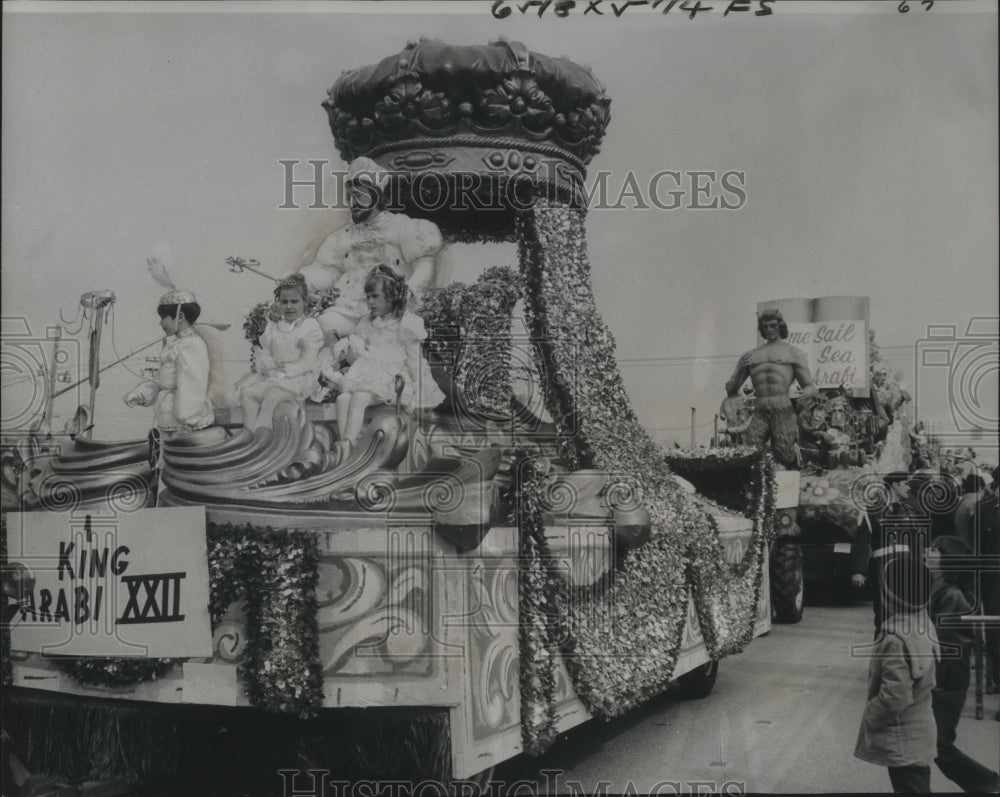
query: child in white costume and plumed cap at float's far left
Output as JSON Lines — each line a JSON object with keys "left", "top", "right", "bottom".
{"left": 125, "top": 290, "right": 215, "bottom": 436}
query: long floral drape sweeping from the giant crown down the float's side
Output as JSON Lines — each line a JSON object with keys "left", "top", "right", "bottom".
{"left": 518, "top": 196, "right": 767, "bottom": 718}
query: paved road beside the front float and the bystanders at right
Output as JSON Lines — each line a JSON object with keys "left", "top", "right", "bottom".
{"left": 494, "top": 604, "right": 1000, "bottom": 794}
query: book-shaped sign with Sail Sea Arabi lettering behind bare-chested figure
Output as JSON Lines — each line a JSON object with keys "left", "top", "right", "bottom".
{"left": 757, "top": 296, "right": 869, "bottom": 398}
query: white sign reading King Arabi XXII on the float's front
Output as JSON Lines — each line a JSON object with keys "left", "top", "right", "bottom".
{"left": 7, "top": 505, "right": 212, "bottom": 658}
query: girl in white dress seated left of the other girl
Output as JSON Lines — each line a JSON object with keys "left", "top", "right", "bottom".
{"left": 236, "top": 274, "right": 323, "bottom": 430}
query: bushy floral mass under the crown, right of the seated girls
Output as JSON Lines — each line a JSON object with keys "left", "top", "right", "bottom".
{"left": 420, "top": 266, "right": 521, "bottom": 417}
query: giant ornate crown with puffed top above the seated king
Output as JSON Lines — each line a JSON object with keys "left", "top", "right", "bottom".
{"left": 323, "top": 40, "right": 611, "bottom": 230}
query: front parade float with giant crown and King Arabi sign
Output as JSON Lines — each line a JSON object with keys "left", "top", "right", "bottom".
{"left": 3, "top": 41, "right": 775, "bottom": 790}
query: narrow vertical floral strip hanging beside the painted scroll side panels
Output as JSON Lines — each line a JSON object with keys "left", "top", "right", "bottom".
{"left": 511, "top": 451, "right": 562, "bottom": 755}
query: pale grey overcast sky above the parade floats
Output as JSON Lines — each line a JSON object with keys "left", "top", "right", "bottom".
{"left": 2, "top": 0, "right": 998, "bottom": 454}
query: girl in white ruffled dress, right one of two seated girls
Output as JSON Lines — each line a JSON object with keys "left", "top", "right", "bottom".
{"left": 321, "top": 265, "right": 444, "bottom": 451}
